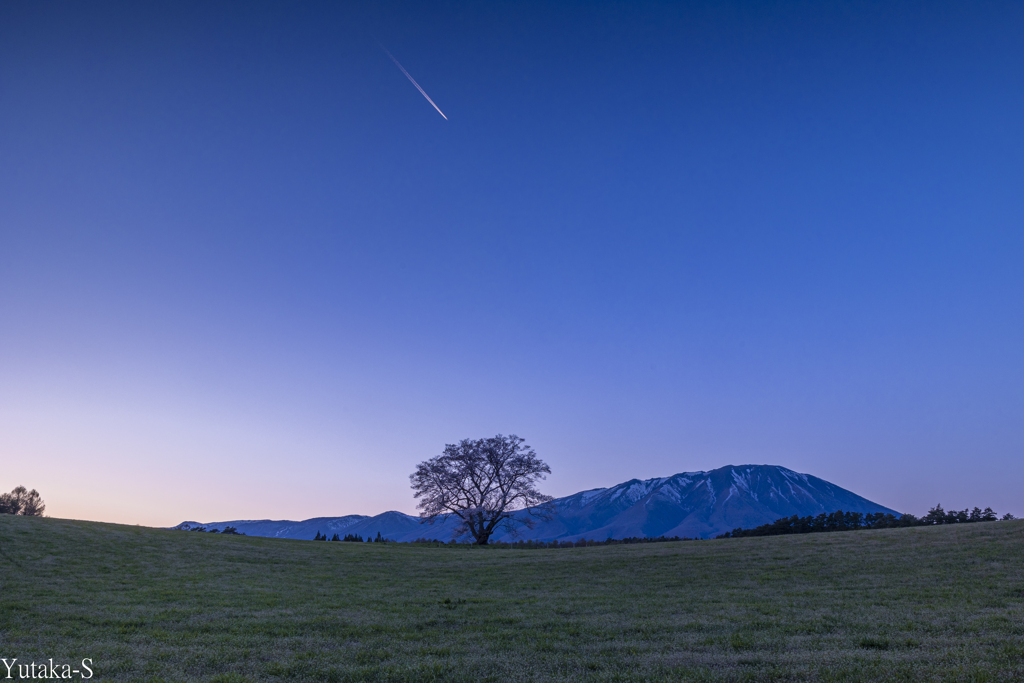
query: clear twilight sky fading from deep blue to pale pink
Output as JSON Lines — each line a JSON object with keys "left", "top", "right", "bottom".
{"left": 0, "top": 2, "right": 1024, "bottom": 526}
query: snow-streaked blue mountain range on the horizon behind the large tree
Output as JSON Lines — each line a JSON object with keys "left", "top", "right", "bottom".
{"left": 174, "top": 465, "right": 899, "bottom": 542}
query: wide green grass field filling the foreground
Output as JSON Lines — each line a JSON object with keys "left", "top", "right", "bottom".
{"left": 0, "top": 515, "right": 1024, "bottom": 683}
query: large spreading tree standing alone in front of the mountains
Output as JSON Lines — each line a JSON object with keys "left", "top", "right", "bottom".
{"left": 409, "top": 434, "right": 553, "bottom": 546}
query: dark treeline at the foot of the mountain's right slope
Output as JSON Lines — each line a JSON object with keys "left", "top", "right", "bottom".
{"left": 716, "top": 505, "right": 1014, "bottom": 539}
